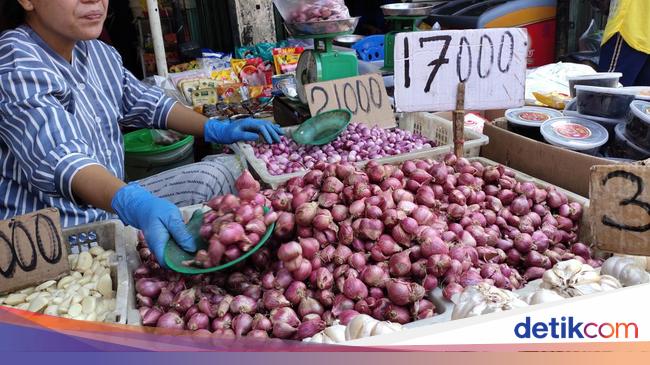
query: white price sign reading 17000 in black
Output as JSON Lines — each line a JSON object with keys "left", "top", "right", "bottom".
{"left": 395, "top": 28, "right": 528, "bottom": 112}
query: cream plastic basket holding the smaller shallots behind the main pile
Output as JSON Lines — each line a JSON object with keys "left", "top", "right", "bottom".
{"left": 234, "top": 113, "right": 490, "bottom": 189}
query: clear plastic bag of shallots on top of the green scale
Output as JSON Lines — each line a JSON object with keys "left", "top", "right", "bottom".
{"left": 273, "top": 0, "right": 350, "bottom": 23}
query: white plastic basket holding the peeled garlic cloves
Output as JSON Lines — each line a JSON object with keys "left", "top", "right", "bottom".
{"left": 62, "top": 220, "right": 133, "bottom": 324}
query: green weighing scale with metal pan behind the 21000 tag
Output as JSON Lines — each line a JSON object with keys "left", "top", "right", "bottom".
{"left": 286, "top": 17, "right": 359, "bottom": 104}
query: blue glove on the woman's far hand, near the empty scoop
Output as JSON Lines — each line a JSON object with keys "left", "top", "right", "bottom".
{"left": 204, "top": 118, "right": 284, "bottom": 144}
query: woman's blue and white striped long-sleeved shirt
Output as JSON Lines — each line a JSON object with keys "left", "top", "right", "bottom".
{"left": 0, "top": 26, "right": 174, "bottom": 227}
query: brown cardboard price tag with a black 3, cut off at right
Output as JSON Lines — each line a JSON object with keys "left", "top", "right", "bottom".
{"left": 590, "top": 165, "right": 650, "bottom": 256}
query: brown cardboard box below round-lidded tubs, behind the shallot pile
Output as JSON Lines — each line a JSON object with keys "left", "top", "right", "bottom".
{"left": 481, "top": 121, "right": 615, "bottom": 197}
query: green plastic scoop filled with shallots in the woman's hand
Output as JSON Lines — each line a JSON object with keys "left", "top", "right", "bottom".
{"left": 165, "top": 207, "right": 275, "bottom": 275}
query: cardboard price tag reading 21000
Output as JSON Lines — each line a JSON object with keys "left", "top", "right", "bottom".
{"left": 305, "top": 74, "right": 396, "bottom": 128}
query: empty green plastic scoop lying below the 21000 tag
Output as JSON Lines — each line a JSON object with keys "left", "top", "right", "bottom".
{"left": 291, "top": 109, "right": 352, "bottom": 146}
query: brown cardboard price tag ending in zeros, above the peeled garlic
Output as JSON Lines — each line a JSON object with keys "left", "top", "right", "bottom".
{"left": 0, "top": 209, "right": 70, "bottom": 293}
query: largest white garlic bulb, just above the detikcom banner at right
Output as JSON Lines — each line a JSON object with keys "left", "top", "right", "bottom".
{"left": 540, "top": 260, "right": 622, "bottom": 298}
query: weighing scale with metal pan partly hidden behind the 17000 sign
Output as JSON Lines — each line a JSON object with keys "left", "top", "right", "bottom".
{"left": 381, "top": 3, "right": 434, "bottom": 72}
